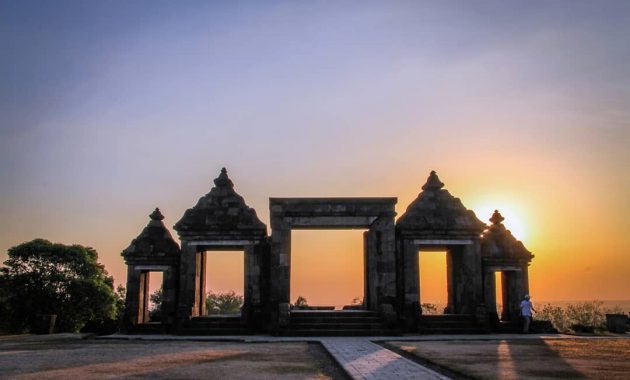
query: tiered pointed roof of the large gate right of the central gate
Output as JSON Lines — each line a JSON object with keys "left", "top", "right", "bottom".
{"left": 396, "top": 171, "right": 486, "bottom": 239}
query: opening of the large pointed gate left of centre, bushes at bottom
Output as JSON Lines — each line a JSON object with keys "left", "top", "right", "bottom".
{"left": 204, "top": 250, "right": 245, "bottom": 315}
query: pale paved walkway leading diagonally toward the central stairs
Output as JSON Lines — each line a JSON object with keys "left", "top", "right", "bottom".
{"left": 320, "top": 338, "right": 449, "bottom": 380}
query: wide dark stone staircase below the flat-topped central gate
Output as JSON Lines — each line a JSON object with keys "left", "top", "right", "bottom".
{"left": 279, "top": 310, "right": 400, "bottom": 336}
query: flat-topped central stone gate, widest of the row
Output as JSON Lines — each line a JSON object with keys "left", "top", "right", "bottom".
{"left": 269, "top": 198, "right": 397, "bottom": 326}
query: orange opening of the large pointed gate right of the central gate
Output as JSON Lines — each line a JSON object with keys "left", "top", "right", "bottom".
{"left": 418, "top": 249, "right": 448, "bottom": 314}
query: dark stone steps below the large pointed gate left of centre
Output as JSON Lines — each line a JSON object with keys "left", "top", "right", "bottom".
{"left": 178, "top": 315, "right": 252, "bottom": 335}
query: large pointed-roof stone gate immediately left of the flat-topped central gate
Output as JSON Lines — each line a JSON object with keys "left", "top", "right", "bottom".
{"left": 174, "top": 168, "right": 267, "bottom": 327}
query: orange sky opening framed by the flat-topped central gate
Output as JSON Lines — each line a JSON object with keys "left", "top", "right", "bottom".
{"left": 290, "top": 230, "right": 365, "bottom": 310}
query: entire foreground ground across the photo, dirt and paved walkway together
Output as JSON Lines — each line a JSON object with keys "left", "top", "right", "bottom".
{"left": 0, "top": 334, "right": 630, "bottom": 380}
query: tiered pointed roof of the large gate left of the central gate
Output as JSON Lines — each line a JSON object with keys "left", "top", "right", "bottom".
{"left": 174, "top": 168, "right": 267, "bottom": 240}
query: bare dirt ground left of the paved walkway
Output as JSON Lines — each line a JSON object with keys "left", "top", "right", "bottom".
{"left": 0, "top": 334, "right": 347, "bottom": 380}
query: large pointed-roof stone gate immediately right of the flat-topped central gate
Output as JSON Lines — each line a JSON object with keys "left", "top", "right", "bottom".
{"left": 396, "top": 171, "right": 486, "bottom": 329}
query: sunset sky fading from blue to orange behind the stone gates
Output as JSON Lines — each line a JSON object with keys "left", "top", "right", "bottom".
{"left": 0, "top": 0, "right": 630, "bottom": 302}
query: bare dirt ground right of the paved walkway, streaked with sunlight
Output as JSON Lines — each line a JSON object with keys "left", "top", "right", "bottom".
{"left": 386, "top": 339, "right": 630, "bottom": 379}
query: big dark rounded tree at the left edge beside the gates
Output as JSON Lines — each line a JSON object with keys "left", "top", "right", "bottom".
{"left": 0, "top": 239, "right": 116, "bottom": 331}
